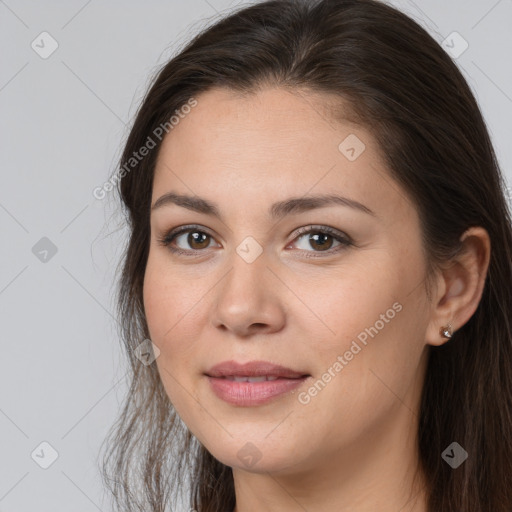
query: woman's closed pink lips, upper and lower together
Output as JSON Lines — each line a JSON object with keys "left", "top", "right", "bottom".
{"left": 205, "top": 361, "right": 310, "bottom": 407}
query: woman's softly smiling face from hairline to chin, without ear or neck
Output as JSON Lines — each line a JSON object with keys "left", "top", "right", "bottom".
{"left": 144, "top": 88, "right": 431, "bottom": 474}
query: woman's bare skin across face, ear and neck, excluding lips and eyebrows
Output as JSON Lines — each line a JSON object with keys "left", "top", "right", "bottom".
{"left": 144, "top": 87, "right": 490, "bottom": 512}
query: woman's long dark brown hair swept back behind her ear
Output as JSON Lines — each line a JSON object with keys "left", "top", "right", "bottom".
{"left": 99, "top": 0, "right": 512, "bottom": 512}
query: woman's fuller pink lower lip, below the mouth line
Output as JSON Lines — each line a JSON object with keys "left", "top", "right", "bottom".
{"left": 204, "top": 377, "right": 308, "bottom": 407}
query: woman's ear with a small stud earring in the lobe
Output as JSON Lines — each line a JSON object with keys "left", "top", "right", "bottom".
{"left": 425, "top": 227, "right": 491, "bottom": 346}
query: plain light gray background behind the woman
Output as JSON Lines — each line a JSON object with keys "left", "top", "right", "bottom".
{"left": 0, "top": 0, "right": 512, "bottom": 512}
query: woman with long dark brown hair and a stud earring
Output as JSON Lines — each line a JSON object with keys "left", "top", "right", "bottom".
{"left": 100, "top": 0, "right": 512, "bottom": 512}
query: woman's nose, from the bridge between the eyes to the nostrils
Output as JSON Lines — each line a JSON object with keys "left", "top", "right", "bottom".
{"left": 212, "top": 246, "right": 287, "bottom": 337}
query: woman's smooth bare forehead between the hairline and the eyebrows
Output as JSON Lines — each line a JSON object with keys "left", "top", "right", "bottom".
{"left": 153, "top": 88, "right": 414, "bottom": 224}
